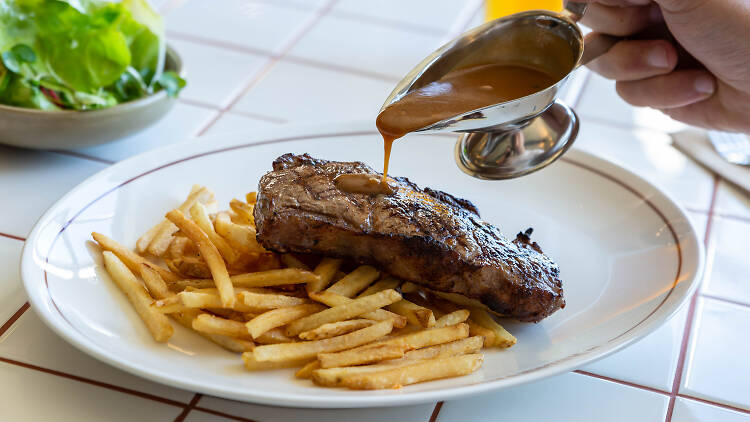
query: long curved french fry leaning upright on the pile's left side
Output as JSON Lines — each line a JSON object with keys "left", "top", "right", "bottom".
{"left": 167, "top": 210, "right": 236, "bottom": 308}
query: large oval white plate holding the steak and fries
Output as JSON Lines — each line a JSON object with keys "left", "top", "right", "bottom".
{"left": 21, "top": 123, "right": 703, "bottom": 407}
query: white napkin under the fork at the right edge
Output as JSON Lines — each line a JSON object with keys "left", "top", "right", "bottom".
{"left": 672, "top": 129, "right": 750, "bottom": 194}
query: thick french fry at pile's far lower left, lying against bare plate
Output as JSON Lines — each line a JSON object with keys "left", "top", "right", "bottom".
{"left": 103, "top": 251, "right": 174, "bottom": 342}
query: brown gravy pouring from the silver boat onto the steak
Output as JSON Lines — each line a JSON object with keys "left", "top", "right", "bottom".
{"left": 358, "top": 64, "right": 558, "bottom": 194}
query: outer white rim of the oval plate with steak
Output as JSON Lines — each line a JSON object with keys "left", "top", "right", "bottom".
{"left": 20, "top": 121, "right": 705, "bottom": 408}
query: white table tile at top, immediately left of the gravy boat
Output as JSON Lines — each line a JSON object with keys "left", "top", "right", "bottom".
{"left": 289, "top": 14, "right": 441, "bottom": 79}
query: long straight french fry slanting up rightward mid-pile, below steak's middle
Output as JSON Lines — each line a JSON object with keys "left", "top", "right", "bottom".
{"left": 286, "top": 290, "right": 401, "bottom": 336}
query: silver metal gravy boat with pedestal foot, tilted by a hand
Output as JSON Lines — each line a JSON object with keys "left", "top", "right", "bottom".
{"left": 381, "top": 2, "right": 616, "bottom": 180}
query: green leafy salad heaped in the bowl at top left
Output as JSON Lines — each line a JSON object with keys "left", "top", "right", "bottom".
{"left": 0, "top": 0, "right": 185, "bottom": 110}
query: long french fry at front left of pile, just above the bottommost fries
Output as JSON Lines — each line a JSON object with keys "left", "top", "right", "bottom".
{"left": 253, "top": 320, "right": 393, "bottom": 362}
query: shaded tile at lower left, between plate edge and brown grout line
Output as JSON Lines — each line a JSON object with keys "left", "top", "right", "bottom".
{"left": 0, "top": 309, "right": 194, "bottom": 403}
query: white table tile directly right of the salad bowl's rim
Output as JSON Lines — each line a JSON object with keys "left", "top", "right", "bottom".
{"left": 169, "top": 37, "right": 269, "bottom": 107}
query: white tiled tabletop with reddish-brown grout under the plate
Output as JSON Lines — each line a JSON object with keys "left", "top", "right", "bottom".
{"left": 0, "top": 0, "right": 750, "bottom": 422}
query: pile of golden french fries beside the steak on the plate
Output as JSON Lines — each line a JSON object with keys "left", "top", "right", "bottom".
{"left": 92, "top": 186, "right": 516, "bottom": 389}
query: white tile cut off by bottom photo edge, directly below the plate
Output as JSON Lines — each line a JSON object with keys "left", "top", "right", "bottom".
{"left": 197, "top": 396, "right": 435, "bottom": 422}
